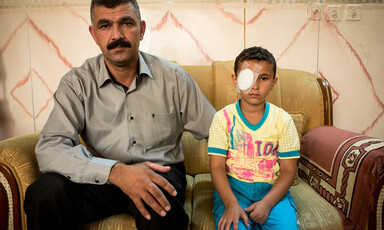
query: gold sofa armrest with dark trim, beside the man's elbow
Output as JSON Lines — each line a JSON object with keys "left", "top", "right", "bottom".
{"left": 0, "top": 133, "right": 40, "bottom": 229}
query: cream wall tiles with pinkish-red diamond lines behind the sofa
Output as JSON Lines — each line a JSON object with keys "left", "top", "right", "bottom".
{"left": 0, "top": 0, "right": 384, "bottom": 140}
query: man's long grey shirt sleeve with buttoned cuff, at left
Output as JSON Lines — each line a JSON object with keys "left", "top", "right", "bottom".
{"left": 36, "top": 78, "right": 116, "bottom": 184}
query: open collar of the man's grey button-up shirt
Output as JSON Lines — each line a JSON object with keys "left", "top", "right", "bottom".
{"left": 97, "top": 52, "right": 153, "bottom": 88}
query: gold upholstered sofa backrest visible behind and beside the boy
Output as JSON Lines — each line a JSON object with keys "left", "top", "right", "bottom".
{"left": 182, "top": 61, "right": 333, "bottom": 175}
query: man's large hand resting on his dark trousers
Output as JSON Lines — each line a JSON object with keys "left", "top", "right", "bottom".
{"left": 109, "top": 162, "right": 177, "bottom": 220}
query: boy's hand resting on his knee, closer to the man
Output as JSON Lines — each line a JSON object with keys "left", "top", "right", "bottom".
{"left": 218, "top": 202, "right": 249, "bottom": 230}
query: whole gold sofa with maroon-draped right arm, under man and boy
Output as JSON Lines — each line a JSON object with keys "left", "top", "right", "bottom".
{"left": 0, "top": 61, "right": 384, "bottom": 230}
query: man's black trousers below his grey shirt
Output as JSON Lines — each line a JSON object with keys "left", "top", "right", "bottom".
{"left": 24, "top": 163, "right": 188, "bottom": 230}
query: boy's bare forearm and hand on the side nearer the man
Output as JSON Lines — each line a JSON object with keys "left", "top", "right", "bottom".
{"left": 210, "top": 155, "right": 249, "bottom": 230}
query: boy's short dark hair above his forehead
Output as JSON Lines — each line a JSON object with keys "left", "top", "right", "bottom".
{"left": 234, "top": 46, "right": 276, "bottom": 78}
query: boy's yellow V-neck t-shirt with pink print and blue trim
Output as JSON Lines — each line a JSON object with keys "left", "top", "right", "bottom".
{"left": 208, "top": 100, "right": 300, "bottom": 184}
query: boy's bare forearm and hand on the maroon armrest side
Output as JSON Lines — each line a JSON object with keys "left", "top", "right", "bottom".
{"left": 245, "top": 158, "right": 297, "bottom": 224}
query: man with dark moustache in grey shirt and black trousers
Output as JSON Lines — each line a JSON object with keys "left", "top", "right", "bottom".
{"left": 25, "top": 0, "right": 215, "bottom": 230}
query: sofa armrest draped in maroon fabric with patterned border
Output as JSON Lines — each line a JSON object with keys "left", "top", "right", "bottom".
{"left": 298, "top": 126, "right": 384, "bottom": 229}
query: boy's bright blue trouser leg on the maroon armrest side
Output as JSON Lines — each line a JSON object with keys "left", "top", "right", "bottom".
{"left": 261, "top": 192, "right": 300, "bottom": 230}
